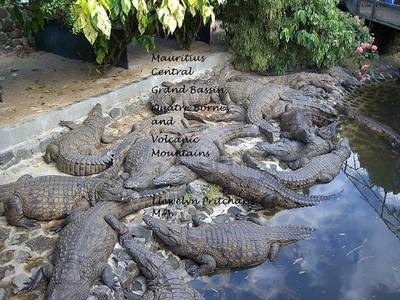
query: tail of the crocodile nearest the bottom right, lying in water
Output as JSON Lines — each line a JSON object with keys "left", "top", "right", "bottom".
{"left": 265, "top": 225, "right": 315, "bottom": 243}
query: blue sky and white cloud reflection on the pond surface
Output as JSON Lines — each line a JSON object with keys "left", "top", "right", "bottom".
{"left": 192, "top": 172, "right": 400, "bottom": 299}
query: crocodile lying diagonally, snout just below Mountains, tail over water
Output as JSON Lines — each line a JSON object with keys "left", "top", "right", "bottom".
{"left": 181, "top": 161, "right": 337, "bottom": 208}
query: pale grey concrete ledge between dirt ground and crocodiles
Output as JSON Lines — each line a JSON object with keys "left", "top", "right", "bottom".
{"left": 0, "top": 52, "right": 231, "bottom": 170}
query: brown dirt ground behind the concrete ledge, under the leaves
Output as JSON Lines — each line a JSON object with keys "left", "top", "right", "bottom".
{"left": 0, "top": 40, "right": 223, "bottom": 127}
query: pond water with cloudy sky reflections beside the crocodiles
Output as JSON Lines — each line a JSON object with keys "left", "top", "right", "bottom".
{"left": 191, "top": 83, "right": 400, "bottom": 300}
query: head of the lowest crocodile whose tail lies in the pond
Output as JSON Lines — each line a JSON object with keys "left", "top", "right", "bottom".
{"left": 143, "top": 215, "right": 185, "bottom": 248}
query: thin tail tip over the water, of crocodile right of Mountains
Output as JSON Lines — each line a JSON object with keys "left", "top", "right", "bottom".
{"left": 277, "top": 187, "right": 341, "bottom": 207}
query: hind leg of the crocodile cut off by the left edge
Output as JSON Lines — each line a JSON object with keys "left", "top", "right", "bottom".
{"left": 4, "top": 195, "right": 40, "bottom": 228}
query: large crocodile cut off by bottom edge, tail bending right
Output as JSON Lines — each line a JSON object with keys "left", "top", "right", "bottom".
{"left": 26, "top": 186, "right": 186, "bottom": 300}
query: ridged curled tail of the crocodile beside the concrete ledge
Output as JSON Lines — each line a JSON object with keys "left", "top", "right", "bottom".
{"left": 57, "top": 151, "right": 114, "bottom": 176}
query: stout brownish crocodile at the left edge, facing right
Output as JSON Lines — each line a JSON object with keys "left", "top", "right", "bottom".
{"left": 0, "top": 175, "right": 127, "bottom": 228}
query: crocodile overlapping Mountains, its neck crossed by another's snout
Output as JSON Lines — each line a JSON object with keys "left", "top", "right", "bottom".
{"left": 153, "top": 125, "right": 260, "bottom": 185}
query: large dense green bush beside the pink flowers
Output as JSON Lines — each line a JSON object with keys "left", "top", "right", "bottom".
{"left": 221, "top": 0, "right": 370, "bottom": 73}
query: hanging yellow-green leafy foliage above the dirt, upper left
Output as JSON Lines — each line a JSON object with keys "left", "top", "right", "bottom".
{"left": 0, "top": 0, "right": 222, "bottom": 66}
